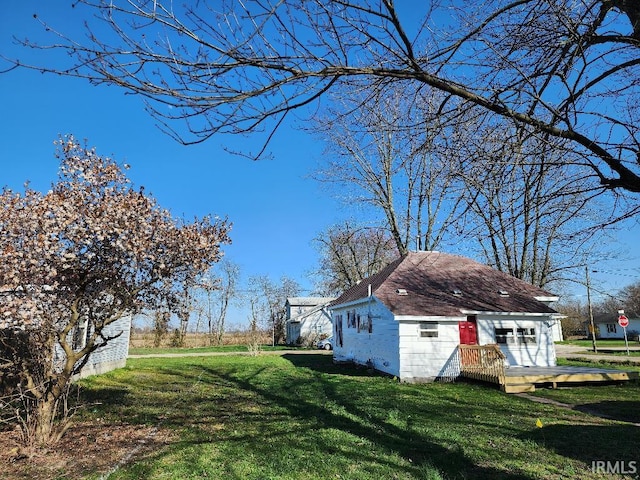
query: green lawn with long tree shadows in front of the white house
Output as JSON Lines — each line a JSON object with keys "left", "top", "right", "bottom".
{"left": 76, "top": 355, "right": 640, "bottom": 480}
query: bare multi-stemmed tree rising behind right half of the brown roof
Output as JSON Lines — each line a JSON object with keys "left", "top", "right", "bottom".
{"left": 458, "top": 121, "right": 599, "bottom": 287}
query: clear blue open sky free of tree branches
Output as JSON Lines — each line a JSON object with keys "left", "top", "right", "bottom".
{"left": 0, "top": 0, "right": 640, "bottom": 323}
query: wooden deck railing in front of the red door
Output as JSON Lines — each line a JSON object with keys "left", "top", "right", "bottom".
{"left": 458, "top": 345, "right": 506, "bottom": 385}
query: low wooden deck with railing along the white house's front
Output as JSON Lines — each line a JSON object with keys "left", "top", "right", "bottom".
{"left": 460, "top": 345, "right": 640, "bottom": 393}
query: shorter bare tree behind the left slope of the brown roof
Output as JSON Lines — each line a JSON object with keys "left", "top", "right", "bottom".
{"left": 314, "top": 222, "right": 399, "bottom": 296}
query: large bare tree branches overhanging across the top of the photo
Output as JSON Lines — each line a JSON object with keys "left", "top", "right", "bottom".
{"left": 8, "top": 0, "right": 640, "bottom": 197}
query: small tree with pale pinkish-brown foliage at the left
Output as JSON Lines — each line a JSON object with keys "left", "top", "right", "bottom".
{"left": 0, "top": 137, "right": 229, "bottom": 444}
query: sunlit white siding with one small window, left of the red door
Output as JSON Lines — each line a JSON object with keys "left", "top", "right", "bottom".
{"left": 398, "top": 317, "right": 460, "bottom": 382}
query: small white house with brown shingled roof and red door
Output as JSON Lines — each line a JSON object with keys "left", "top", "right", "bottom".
{"left": 331, "top": 252, "right": 559, "bottom": 382}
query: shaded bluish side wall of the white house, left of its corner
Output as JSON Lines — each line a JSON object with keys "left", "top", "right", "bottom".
{"left": 332, "top": 297, "right": 400, "bottom": 376}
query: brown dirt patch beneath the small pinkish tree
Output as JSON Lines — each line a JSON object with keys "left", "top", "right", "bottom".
{"left": 0, "top": 422, "right": 171, "bottom": 480}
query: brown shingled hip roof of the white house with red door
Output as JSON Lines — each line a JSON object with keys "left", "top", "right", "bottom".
{"left": 332, "top": 252, "right": 555, "bottom": 316}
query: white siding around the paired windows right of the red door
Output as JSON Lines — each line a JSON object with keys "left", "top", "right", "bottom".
{"left": 478, "top": 315, "right": 556, "bottom": 367}
